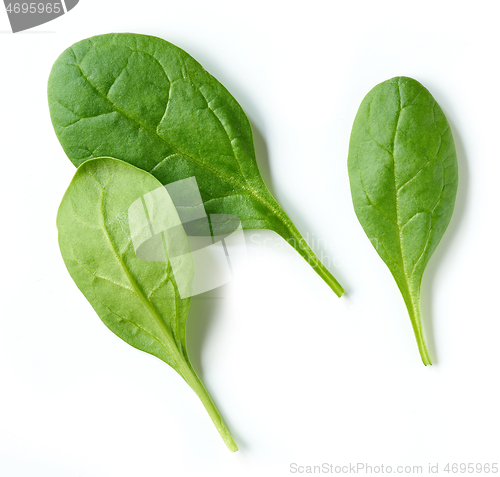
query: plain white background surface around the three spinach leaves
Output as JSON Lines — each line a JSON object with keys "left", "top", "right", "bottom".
{"left": 0, "top": 0, "right": 500, "bottom": 477}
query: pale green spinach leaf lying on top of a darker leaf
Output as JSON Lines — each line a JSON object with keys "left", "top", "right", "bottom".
{"left": 57, "top": 158, "right": 238, "bottom": 452}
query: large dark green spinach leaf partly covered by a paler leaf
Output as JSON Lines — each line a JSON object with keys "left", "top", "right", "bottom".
{"left": 48, "top": 33, "right": 344, "bottom": 296}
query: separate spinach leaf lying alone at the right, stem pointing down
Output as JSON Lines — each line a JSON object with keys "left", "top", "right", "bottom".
{"left": 348, "top": 77, "right": 458, "bottom": 365}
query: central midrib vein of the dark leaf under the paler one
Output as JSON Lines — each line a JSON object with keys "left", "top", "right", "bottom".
{"left": 74, "top": 57, "right": 285, "bottom": 220}
